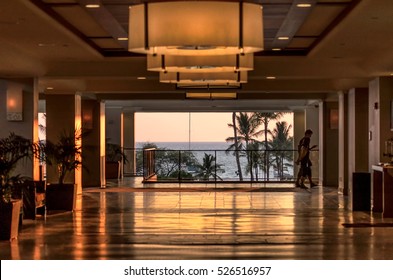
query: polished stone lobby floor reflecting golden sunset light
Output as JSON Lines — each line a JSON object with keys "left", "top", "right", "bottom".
{"left": 0, "top": 179, "right": 393, "bottom": 260}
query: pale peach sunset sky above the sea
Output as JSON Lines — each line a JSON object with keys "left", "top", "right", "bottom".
{"left": 135, "top": 112, "right": 293, "bottom": 143}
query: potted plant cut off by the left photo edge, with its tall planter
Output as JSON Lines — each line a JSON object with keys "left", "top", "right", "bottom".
{"left": 0, "top": 133, "right": 33, "bottom": 240}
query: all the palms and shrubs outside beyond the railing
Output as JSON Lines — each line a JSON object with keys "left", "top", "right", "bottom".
{"left": 137, "top": 112, "right": 294, "bottom": 181}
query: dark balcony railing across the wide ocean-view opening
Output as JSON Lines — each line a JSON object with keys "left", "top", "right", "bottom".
{"left": 142, "top": 149, "right": 319, "bottom": 183}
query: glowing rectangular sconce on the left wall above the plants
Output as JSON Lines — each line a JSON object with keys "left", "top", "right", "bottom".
{"left": 7, "top": 84, "right": 23, "bottom": 121}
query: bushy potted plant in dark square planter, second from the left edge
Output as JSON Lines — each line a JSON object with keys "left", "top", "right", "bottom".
{"left": 44, "top": 130, "right": 82, "bottom": 211}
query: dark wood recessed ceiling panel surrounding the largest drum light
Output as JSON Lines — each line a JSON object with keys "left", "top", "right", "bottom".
{"left": 32, "top": 0, "right": 360, "bottom": 57}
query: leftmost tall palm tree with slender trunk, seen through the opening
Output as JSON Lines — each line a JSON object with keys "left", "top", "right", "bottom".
{"left": 226, "top": 112, "right": 262, "bottom": 180}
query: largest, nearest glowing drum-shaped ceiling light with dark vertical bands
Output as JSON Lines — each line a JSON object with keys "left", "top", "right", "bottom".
{"left": 128, "top": 1, "right": 263, "bottom": 55}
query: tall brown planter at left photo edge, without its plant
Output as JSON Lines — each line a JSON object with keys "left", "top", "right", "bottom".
{"left": 0, "top": 199, "right": 22, "bottom": 240}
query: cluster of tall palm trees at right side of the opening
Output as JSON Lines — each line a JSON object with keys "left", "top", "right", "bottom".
{"left": 226, "top": 112, "right": 293, "bottom": 181}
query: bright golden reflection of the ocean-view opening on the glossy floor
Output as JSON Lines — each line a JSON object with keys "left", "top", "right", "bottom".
{"left": 131, "top": 192, "right": 294, "bottom": 234}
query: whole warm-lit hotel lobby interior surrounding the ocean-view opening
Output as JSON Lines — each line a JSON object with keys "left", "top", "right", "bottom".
{"left": 0, "top": 0, "right": 393, "bottom": 260}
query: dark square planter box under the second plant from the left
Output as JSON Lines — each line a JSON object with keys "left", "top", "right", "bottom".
{"left": 45, "top": 184, "right": 76, "bottom": 211}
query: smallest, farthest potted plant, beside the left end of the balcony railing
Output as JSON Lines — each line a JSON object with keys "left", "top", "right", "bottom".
{"left": 105, "top": 143, "right": 127, "bottom": 179}
